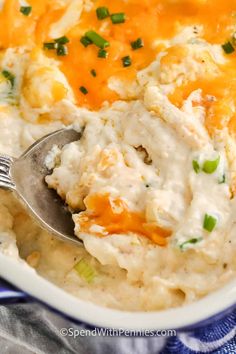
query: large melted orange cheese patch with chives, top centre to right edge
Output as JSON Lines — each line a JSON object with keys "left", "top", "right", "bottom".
{"left": 55, "top": 0, "right": 234, "bottom": 109}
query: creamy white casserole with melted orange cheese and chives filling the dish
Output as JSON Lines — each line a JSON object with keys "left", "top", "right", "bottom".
{"left": 0, "top": 0, "right": 236, "bottom": 311}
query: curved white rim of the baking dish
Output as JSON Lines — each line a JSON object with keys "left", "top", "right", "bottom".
{"left": 0, "top": 253, "right": 236, "bottom": 331}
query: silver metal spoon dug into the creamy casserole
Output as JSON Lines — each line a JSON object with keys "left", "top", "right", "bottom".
{"left": 0, "top": 129, "right": 82, "bottom": 245}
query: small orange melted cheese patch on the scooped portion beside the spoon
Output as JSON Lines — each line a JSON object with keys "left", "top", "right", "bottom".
{"left": 74, "top": 194, "right": 171, "bottom": 246}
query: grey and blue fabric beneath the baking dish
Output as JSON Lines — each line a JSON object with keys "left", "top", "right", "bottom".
{"left": 0, "top": 303, "right": 236, "bottom": 354}
